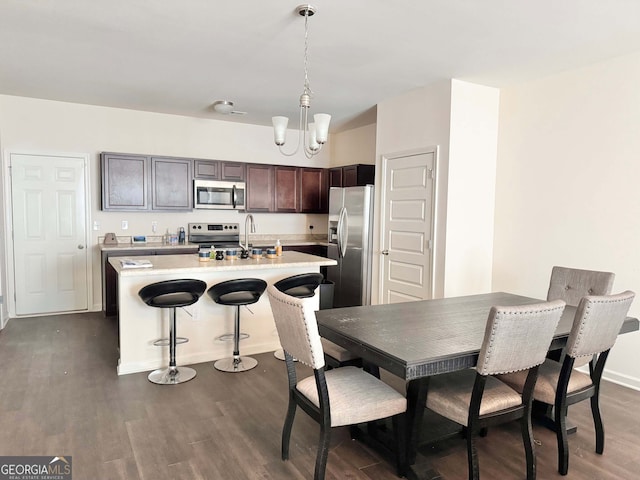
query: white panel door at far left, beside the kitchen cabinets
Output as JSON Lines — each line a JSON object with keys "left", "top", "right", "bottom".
{"left": 10, "top": 154, "right": 88, "bottom": 315}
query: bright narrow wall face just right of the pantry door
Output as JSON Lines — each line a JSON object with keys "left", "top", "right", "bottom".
{"left": 444, "top": 80, "right": 500, "bottom": 297}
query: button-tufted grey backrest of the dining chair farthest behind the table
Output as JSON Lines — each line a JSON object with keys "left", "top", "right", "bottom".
{"left": 547, "top": 266, "right": 615, "bottom": 307}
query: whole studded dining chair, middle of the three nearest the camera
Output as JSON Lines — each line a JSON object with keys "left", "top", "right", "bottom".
{"left": 427, "top": 300, "right": 565, "bottom": 480}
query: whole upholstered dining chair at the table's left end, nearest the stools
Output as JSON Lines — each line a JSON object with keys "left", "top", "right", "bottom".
{"left": 267, "top": 285, "right": 407, "bottom": 480}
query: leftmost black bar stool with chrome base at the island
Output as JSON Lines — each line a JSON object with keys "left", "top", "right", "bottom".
{"left": 138, "top": 279, "right": 207, "bottom": 385}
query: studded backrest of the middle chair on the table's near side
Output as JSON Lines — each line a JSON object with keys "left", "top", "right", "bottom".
{"left": 476, "top": 300, "right": 565, "bottom": 375}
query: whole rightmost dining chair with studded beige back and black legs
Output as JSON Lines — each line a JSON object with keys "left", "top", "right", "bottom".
{"left": 499, "top": 291, "right": 635, "bottom": 475}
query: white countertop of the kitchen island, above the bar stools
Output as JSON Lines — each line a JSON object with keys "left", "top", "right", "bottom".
{"left": 109, "top": 249, "right": 337, "bottom": 277}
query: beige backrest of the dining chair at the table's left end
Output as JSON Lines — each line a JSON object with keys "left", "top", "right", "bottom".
{"left": 267, "top": 285, "right": 324, "bottom": 370}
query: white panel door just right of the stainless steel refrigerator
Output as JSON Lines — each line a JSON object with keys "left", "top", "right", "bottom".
{"left": 381, "top": 150, "right": 436, "bottom": 303}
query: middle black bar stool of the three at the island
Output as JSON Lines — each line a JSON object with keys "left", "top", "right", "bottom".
{"left": 207, "top": 278, "right": 267, "bottom": 372}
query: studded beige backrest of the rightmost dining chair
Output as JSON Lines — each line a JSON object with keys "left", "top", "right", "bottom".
{"left": 566, "top": 290, "right": 635, "bottom": 358}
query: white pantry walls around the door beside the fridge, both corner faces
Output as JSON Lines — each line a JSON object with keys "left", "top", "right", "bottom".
{"left": 373, "top": 80, "right": 499, "bottom": 297}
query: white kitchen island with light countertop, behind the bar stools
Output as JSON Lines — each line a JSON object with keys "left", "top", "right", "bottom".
{"left": 109, "top": 251, "right": 336, "bottom": 375}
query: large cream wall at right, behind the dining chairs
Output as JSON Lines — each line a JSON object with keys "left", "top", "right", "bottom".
{"left": 493, "top": 54, "right": 640, "bottom": 388}
